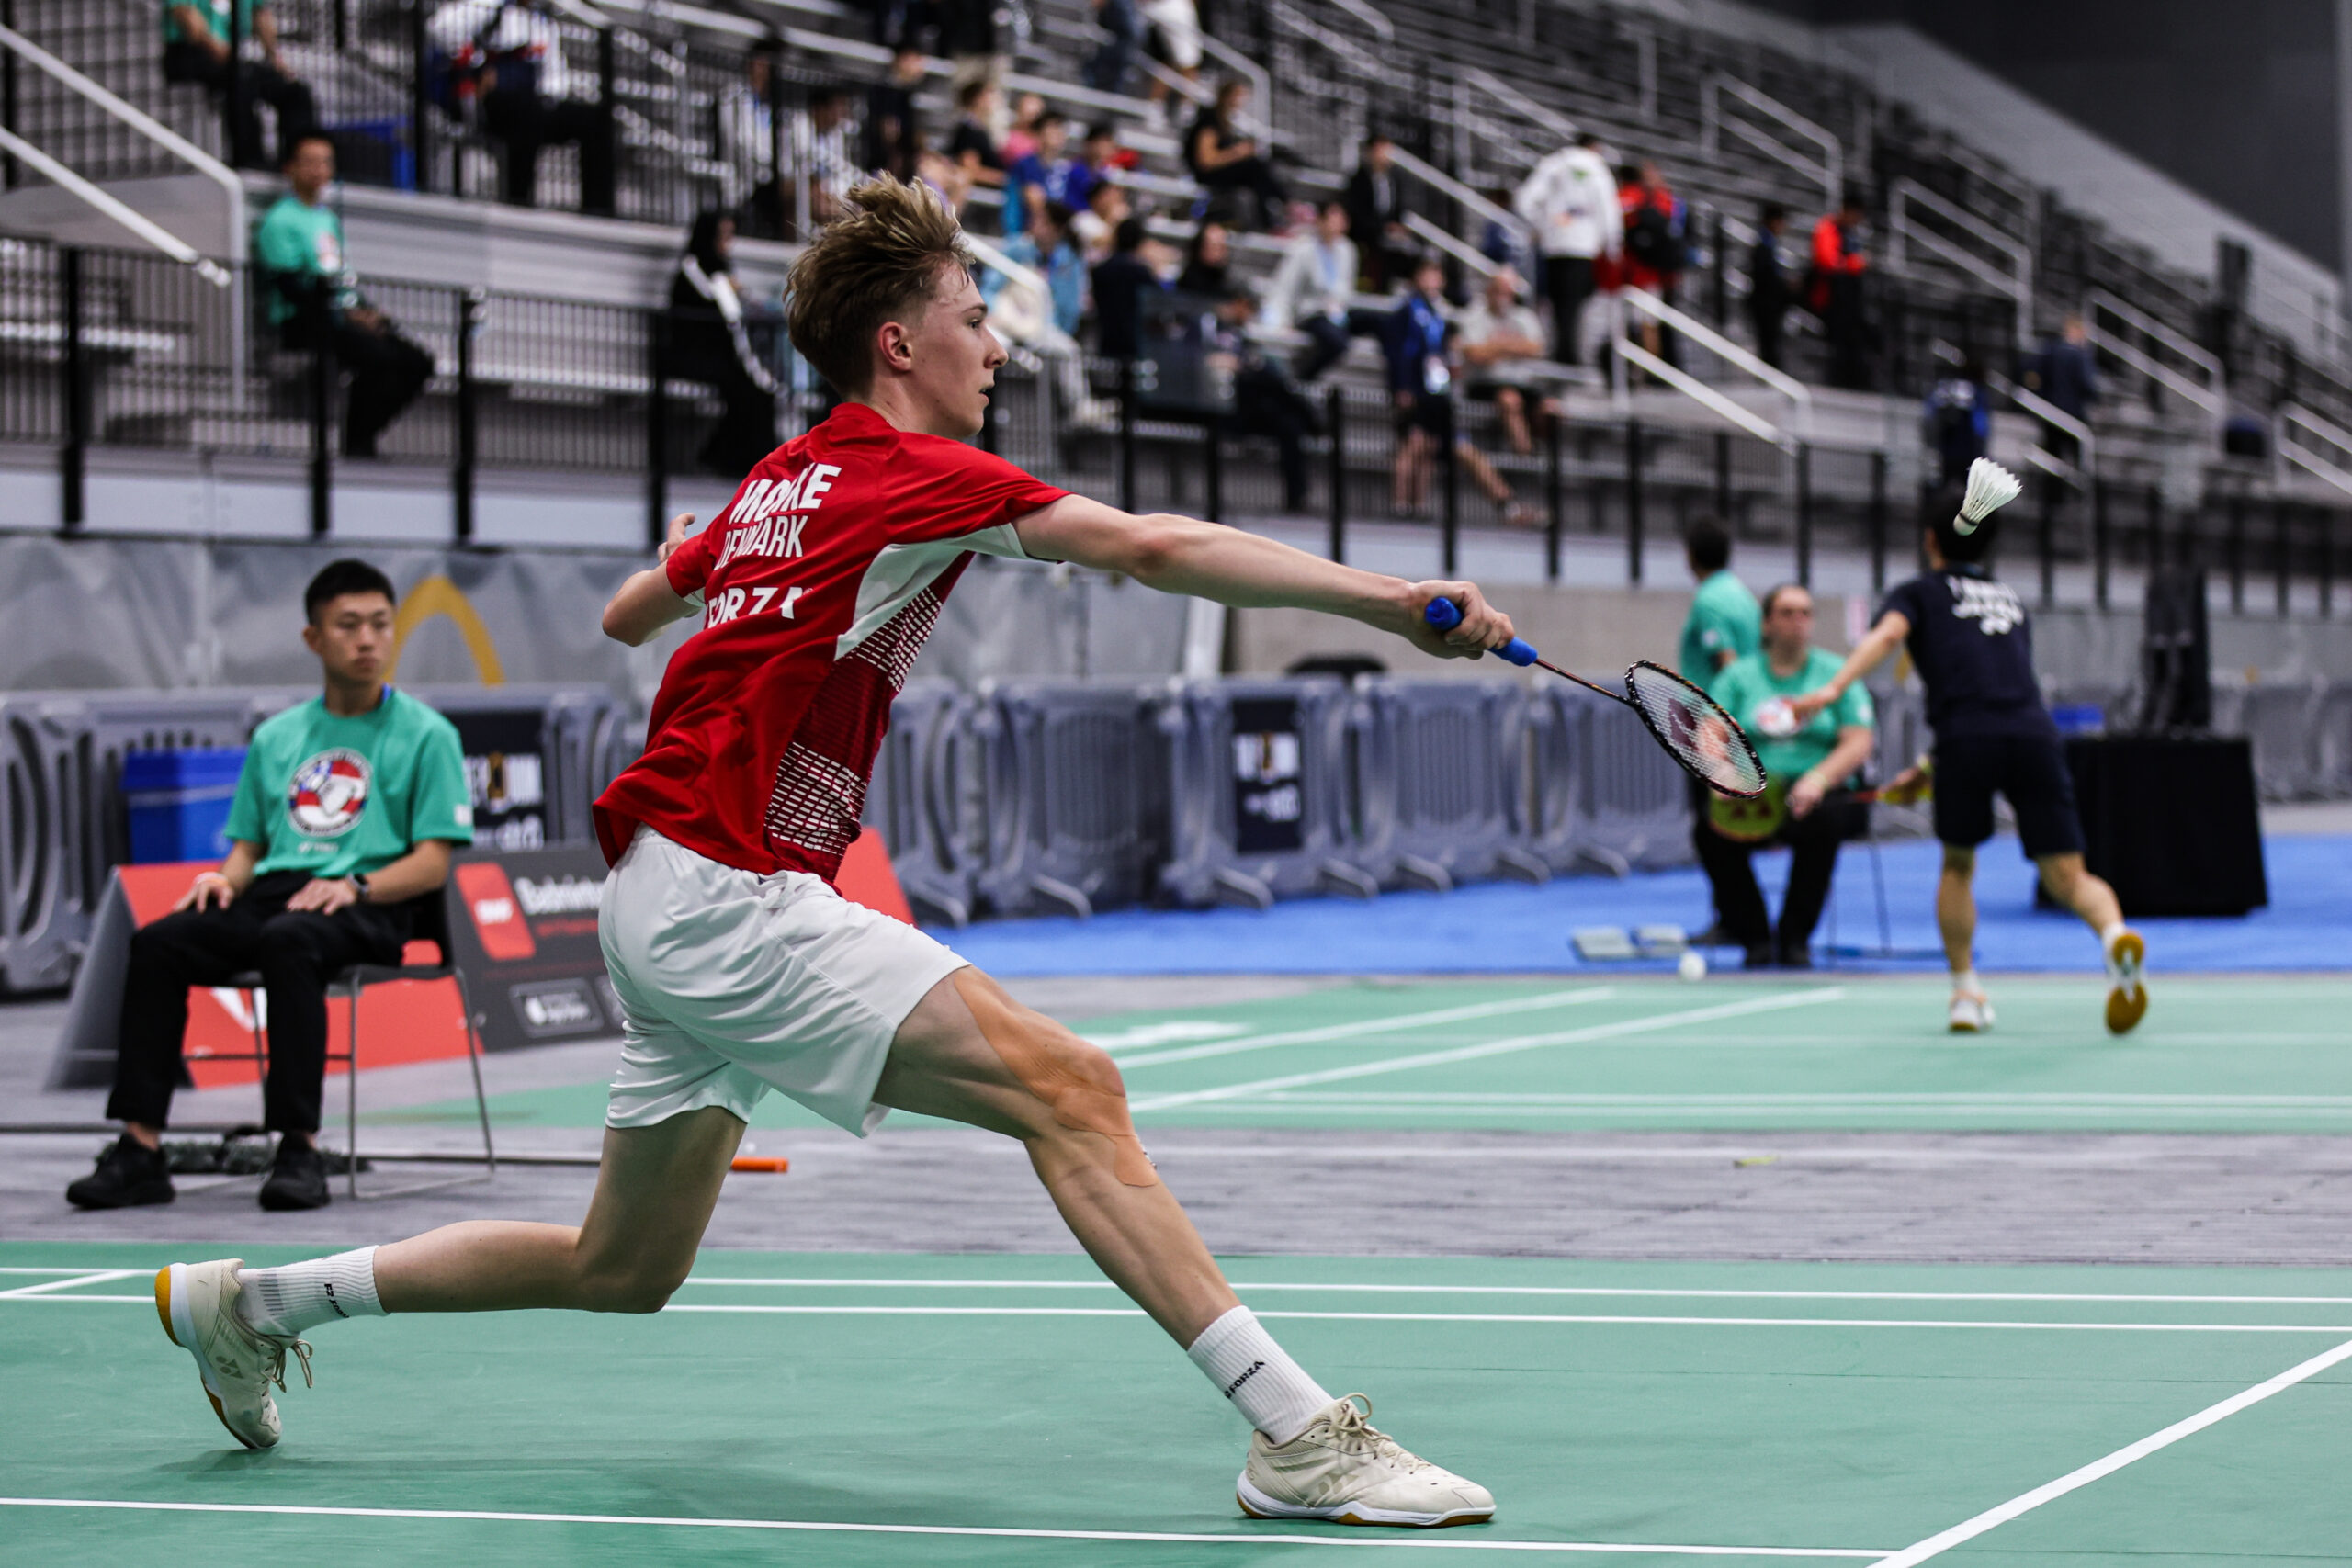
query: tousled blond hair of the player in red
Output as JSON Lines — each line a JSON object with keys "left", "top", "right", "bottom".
{"left": 786, "top": 174, "right": 974, "bottom": 395}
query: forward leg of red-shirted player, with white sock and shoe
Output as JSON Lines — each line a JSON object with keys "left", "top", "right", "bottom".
{"left": 875, "top": 968, "right": 1494, "bottom": 1526}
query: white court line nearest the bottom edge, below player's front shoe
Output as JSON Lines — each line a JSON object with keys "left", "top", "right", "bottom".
{"left": 0, "top": 1497, "right": 1886, "bottom": 1556}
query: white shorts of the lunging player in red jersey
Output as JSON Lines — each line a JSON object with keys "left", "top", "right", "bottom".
{"left": 597, "top": 828, "right": 965, "bottom": 1138}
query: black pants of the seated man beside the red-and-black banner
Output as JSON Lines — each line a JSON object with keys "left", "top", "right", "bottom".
{"left": 106, "top": 872, "right": 413, "bottom": 1134}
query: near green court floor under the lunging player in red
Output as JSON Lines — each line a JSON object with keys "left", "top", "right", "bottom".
{"left": 0, "top": 1244, "right": 2352, "bottom": 1568}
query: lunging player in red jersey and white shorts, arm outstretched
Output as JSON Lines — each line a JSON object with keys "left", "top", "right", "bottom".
{"left": 155, "top": 181, "right": 1512, "bottom": 1526}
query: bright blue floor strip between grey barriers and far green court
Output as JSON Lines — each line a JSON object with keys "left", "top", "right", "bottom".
{"left": 938, "top": 837, "right": 2352, "bottom": 976}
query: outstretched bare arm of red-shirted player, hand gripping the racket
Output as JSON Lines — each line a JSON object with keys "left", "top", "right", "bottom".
{"left": 1013, "top": 496, "right": 1512, "bottom": 659}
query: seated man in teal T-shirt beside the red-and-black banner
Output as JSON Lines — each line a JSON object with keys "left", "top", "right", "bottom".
{"left": 66, "top": 562, "right": 473, "bottom": 1208}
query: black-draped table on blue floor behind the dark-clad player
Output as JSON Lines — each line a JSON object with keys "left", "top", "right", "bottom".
{"left": 2065, "top": 736, "right": 2269, "bottom": 917}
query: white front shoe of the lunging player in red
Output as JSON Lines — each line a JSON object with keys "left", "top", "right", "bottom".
{"left": 1235, "top": 1394, "right": 1494, "bottom": 1530}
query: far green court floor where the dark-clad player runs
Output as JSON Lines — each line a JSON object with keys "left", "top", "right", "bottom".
{"left": 379, "top": 974, "right": 2352, "bottom": 1134}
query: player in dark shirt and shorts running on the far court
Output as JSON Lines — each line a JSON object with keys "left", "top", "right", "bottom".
{"left": 1790, "top": 482, "right": 2147, "bottom": 1034}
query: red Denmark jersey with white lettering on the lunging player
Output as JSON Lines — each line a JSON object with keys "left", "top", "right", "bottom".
{"left": 595, "top": 402, "right": 1068, "bottom": 882}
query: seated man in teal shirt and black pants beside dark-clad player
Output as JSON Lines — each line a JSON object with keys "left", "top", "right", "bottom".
{"left": 1693, "top": 583, "right": 1872, "bottom": 968}
